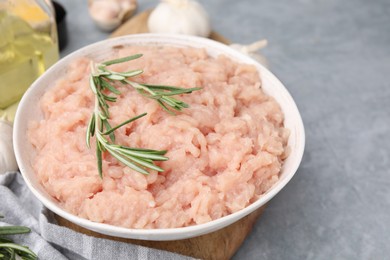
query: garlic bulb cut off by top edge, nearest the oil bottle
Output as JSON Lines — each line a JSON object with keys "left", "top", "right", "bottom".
{"left": 88, "top": 0, "right": 137, "bottom": 31}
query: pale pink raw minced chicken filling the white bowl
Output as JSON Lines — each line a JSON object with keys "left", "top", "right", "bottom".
{"left": 28, "top": 46, "right": 289, "bottom": 229}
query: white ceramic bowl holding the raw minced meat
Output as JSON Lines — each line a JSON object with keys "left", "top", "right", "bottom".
{"left": 13, "top": 34, "right": 305, "bottom": 240}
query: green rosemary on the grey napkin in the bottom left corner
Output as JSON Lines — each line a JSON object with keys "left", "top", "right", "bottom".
{"left": 0, "top": 216, "right": 38, "bottom": 260}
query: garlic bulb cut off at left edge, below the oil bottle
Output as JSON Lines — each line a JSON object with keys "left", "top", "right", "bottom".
{"left": 0, "top": 119, "right": 18, "bottom": 174}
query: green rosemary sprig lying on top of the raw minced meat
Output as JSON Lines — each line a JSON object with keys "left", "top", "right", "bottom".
{"left": 86, "top": 54, "right": 201, "bottom": 178}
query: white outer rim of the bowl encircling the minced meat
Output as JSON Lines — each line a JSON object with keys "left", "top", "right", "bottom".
{"left": 13, "top": 33, "right": 305, "bottom": 241}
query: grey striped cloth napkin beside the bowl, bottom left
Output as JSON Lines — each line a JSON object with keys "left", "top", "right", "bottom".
{"left": 0, "top": 172, "right": 192, "bottom": 260}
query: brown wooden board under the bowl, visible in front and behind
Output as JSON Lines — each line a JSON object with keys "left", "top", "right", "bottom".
{"left": 56, "top": 10, "right": 265, "bottom": 260}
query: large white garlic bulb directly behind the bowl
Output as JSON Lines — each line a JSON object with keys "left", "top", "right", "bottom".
{"left": 148, "top": 0, "right": 211, "bottom": 37}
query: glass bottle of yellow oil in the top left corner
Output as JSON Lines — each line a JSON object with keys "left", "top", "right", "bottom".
{"left": 0, "top": 0, "right": 59, "bottom": 121}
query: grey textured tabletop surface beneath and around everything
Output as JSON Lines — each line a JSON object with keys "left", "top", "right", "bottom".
{"left": 55, "top": 0, "right": 390, "bottom": 259}
